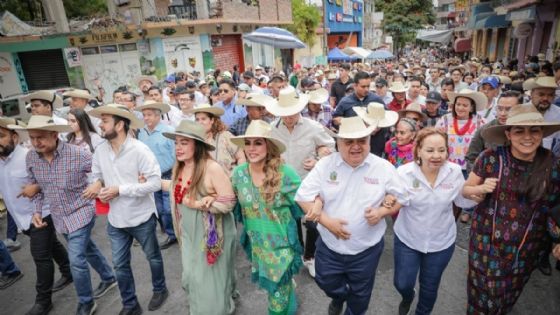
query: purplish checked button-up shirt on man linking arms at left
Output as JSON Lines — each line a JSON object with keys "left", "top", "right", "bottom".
{"left": 26, "top": 140, "right": 95, "bottom": 234}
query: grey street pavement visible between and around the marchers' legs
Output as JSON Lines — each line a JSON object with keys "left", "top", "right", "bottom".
{"left": 0, "top": 216, "right": 560, "bottom": 315}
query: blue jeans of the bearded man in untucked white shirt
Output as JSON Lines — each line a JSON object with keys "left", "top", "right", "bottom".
{"left": 107, "top": 215, "right": 166, "bottom": 308}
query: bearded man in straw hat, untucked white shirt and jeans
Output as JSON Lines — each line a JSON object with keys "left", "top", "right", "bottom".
{"left": 83, "top": 104, "right": 168, "bottom": 314}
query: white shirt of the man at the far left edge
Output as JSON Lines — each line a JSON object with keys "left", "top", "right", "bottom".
{"left": 0, "top": 145, "right": 50, "bottom": 231}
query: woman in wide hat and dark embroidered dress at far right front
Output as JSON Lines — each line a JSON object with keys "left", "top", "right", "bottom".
{"left": 463, "top": 104, "right": 560, "bottom": 314}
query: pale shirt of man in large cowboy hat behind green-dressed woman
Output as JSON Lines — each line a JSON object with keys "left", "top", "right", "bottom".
{"left": 271, "top": 115, "right": 334, "bottom": 179}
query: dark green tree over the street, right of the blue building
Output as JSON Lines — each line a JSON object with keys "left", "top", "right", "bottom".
{"left": 375, "top": 0, "right": 436, "bottom": 56}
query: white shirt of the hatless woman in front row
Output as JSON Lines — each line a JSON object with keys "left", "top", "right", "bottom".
{"left": 394, "top": 162, "right": 476, "bottom": 253}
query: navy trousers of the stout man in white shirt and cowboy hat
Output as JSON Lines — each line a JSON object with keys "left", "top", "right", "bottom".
{"left": 315, "top": 237, "right": 384, "bottom": 315}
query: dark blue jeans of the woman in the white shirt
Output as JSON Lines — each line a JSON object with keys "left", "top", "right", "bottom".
{"left": 393, "top": 235, "right": 455, "bottom": 315}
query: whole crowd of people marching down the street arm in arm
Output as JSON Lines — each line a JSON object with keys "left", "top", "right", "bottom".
{"left": 0, "top": 54, "right": 560, "bottom": 315}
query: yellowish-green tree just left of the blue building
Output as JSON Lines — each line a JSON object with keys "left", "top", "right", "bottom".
{"left": 287, "top": 0, "right": 321, "bottom": 49}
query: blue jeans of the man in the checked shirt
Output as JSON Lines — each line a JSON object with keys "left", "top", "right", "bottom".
{"left": 64, "top": 217, "right": 115, "bottom": 304}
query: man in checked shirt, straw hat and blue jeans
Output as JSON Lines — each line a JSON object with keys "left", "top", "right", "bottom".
{"left": 8, "top": 115, "right": 116, "bottom": 315}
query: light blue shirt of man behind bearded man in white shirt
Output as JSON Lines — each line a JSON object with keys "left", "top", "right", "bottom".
{"left": 138, "top": 122, "right": 175, "bottom": 174}
